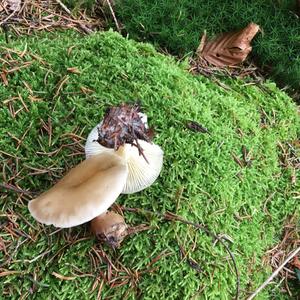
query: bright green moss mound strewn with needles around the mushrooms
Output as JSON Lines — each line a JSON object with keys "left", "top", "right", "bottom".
{"left": 0, "top": 32, "right": 300, "bottom": 300}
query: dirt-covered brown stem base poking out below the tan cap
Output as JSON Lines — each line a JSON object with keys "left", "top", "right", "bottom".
{"left": 91, "top": 211, "right": 127, "bottom": 248}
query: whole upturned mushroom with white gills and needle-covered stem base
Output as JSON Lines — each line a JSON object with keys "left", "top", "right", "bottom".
{"left": 85, "top": 104, "right": 163, "bottom": 194}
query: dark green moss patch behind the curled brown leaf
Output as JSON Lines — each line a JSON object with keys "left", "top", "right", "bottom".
{"left": 115, "top": 0, "right": 300, "bottom": 91}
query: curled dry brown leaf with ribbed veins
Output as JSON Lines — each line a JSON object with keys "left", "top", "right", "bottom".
{"left": 197, "top": 23, "right": 259, "bottom": 67}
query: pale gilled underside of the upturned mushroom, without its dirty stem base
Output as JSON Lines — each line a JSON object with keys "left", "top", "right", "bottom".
{"left": 85, "top": 123, "right": 163, "bottom": 194}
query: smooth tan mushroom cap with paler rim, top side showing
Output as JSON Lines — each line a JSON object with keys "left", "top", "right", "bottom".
{"left": 28, "top": 153, "right": 128, "bottom": 228}
